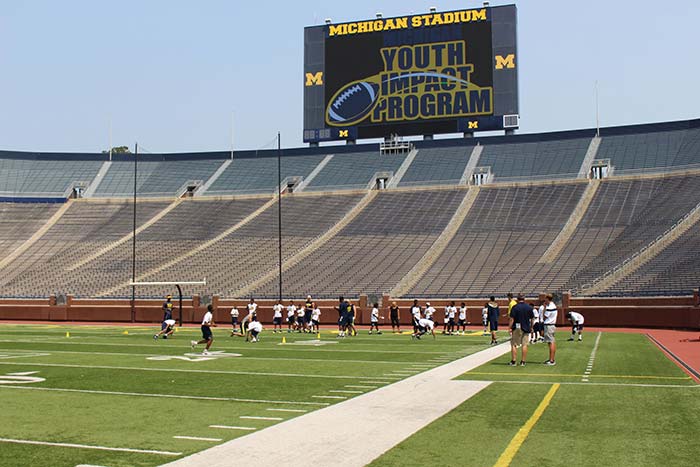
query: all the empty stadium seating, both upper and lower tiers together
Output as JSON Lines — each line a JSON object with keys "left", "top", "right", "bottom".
{"left": 0, "top": 117, "right": 700, "bottom": 298}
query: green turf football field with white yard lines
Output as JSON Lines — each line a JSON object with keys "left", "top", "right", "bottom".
{"left": 0, "top": 324, "right": 700, "bottom": 467}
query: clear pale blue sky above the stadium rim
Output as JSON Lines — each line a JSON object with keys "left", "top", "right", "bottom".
{"left": 0, "top": 0, "right": 700, "bottom": 152}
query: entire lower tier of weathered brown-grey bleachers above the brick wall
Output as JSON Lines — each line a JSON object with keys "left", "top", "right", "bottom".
{"left": 0, "top": 173, "right": 700, "bottom": 298}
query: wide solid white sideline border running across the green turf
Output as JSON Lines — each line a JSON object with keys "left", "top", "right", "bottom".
{"left": 159, "top": 343, "right": 510, "bottom": 467}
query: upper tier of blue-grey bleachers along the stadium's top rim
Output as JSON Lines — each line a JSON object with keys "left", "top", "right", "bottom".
{"left": 0, "top": 120, "right": 700, "bottom": 198}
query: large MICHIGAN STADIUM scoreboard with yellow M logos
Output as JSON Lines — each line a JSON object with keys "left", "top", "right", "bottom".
{"left": 304, "top": 5, "right": 519, "bottom": 143}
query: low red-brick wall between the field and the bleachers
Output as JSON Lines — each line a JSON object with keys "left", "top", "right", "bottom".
{"left": 0, "top": 296, "right": 700, "bottom": 329}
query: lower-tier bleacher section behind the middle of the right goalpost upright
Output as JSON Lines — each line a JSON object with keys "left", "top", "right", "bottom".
{"left": 106, "top": 193, "right": 363, "bottom": 296}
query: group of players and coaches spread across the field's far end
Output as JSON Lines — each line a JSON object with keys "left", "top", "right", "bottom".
{"left": 153, "top": 294, "right": 584, "bottom": 356}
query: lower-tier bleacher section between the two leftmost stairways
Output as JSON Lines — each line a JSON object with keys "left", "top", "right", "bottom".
{"left": 0, "top": 200, "right": 171, "bottom": 297}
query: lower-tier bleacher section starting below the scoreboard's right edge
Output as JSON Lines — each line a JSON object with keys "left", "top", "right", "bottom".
{"left": 405, "top": 182, "right": 587, "bottom": 298}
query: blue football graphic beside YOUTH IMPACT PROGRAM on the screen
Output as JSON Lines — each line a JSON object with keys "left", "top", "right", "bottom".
{"left": 326, "top": 81, "right": 379, "bottom": 125}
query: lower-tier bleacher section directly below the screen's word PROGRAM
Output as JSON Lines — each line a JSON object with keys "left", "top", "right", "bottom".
{"left": 252, "top": 189, "right": 467, "bottom": 298}
